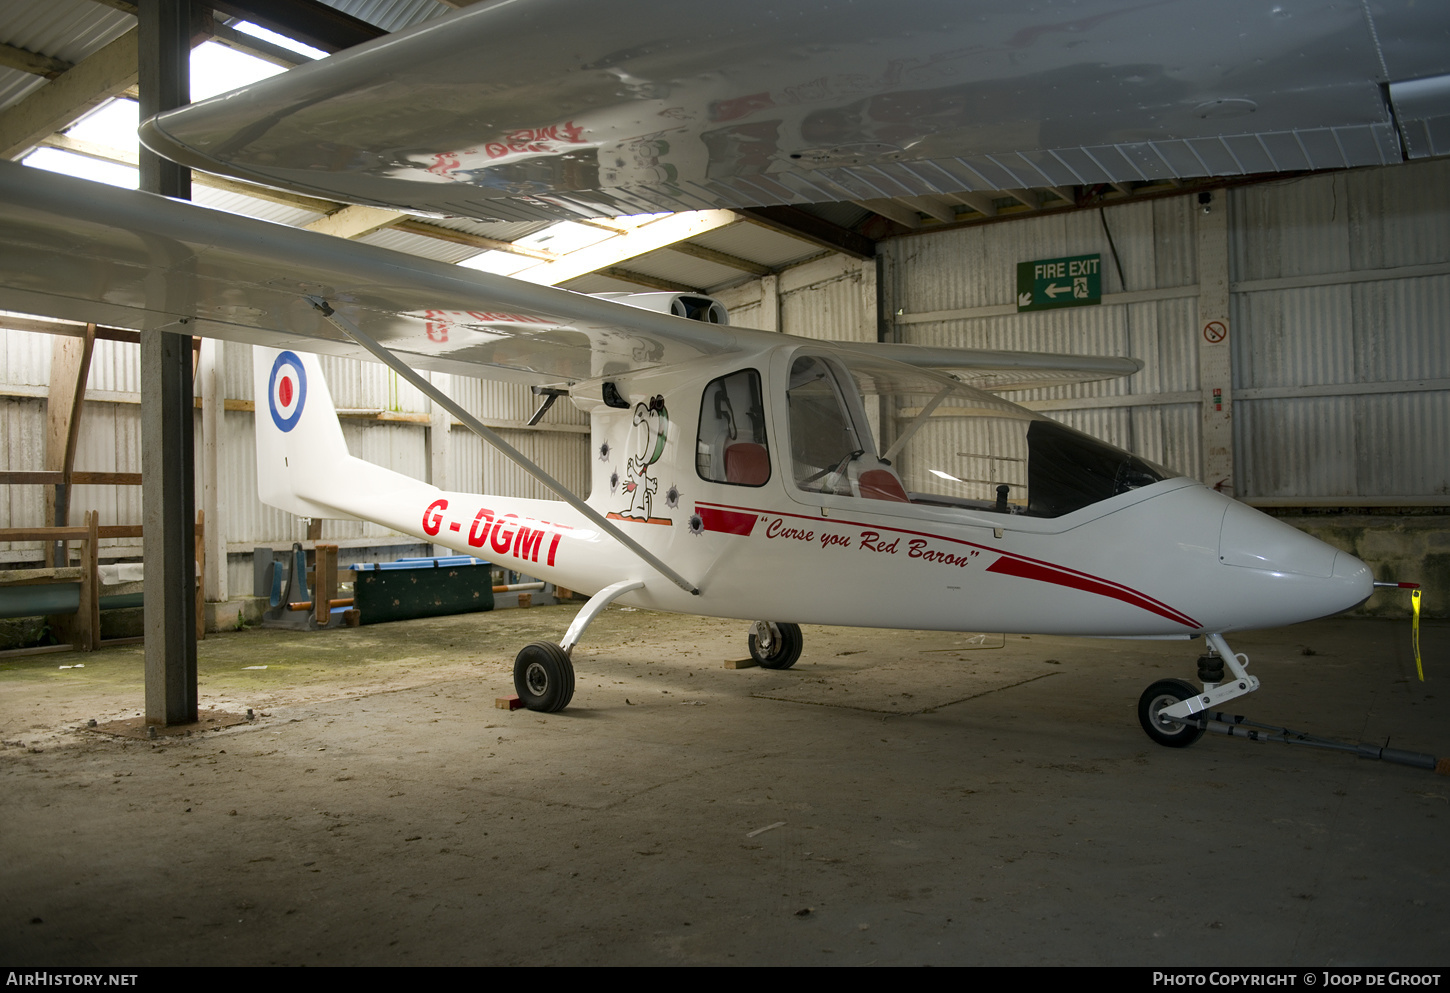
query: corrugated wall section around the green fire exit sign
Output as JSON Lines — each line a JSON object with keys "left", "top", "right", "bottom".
{"left": 886, "top": 197, "right": 1201, "bottom": 475}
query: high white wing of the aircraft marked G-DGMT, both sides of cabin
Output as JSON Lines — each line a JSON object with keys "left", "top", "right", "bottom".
{"left": 0, "top": 162, "right": 1140, "bottom": 390}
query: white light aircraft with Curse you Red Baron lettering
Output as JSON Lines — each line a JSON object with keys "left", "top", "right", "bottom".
{"left": 0, "top": 165, "right": 1373, "bottom": 745}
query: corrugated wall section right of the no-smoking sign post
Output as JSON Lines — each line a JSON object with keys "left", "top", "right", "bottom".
{"left": 1230, "top": 159, "right": 1450, "bottom": 504}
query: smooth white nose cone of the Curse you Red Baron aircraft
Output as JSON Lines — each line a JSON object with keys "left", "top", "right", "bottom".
{"left": 1218, "top": 502, "right": 1375, "bottom": 623}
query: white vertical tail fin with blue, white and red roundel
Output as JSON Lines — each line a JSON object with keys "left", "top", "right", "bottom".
{"left": 252, "top": 346, "right": 351, "bottom": 518}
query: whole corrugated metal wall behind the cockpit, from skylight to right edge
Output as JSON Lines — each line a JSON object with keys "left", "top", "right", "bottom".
{"left": 719, "top": 161, "right": 1450, "bottom": 506}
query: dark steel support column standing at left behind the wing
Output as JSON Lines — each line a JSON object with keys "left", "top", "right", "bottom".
{"left": 139, "top": 0, "right": 197, "bottom": 725}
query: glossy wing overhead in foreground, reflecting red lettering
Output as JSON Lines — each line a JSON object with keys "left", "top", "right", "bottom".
{"left": 142, "top": 0, "right": 1450, "bottom": 219}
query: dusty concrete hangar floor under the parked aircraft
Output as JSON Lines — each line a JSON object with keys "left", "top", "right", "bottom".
{"left": 0, "top": 606, "right": 1450, "bottom": 965}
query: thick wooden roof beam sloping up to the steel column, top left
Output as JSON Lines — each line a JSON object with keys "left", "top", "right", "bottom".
{"left": 0, "top": 29, "right": 136, "bottom": 158}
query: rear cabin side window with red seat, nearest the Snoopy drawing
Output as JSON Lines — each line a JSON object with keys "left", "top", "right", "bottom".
{"left": 695, "top": 370, "right": 770, "bottom": 486}
